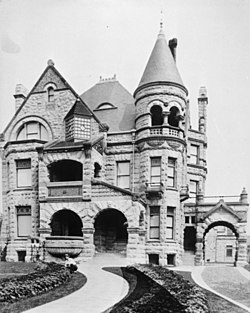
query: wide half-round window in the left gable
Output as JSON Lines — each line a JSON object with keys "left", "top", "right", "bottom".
{"left": 17, "top": 122, "right": 49, "bottom": 141}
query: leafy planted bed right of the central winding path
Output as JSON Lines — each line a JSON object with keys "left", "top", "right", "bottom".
{"left": 130, "top": 264, "right": 210, "bottom": 313}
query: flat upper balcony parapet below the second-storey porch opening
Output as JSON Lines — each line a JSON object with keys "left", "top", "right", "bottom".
{"left": 47, "top": 181, "right": 82, "bottom": 198}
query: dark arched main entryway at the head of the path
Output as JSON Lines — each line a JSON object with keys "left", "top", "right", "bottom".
{"left": 94, "top": 209, "right": 128, "bottom": 254}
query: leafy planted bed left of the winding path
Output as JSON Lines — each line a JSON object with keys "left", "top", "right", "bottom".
{"left": 0, "top": 263, "right": 71, "bottom": 302}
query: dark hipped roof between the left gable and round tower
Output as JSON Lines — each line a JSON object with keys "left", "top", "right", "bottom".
{"left": 81, "top": 79, "right": 135, "bottom": 132}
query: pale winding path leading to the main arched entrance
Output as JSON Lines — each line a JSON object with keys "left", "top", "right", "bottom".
{"left": 25, "top": 254, "right": 129, "bottom": 313}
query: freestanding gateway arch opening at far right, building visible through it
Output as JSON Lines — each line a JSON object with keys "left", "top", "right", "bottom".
{"left": 203, "top": 221, "right": 239, "bottom": 265}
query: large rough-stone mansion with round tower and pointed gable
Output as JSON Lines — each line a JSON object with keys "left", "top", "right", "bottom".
{"left": 0, "top": 30, "right": 248, "bottom": 266}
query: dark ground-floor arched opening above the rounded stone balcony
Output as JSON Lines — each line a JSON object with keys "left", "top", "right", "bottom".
{"left": 50, "top": 209, "right": 83, "bottom": 237}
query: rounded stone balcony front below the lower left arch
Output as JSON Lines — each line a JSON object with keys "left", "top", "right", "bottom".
{"left": 44, "top": 236, "right": 83, "bottom": 257}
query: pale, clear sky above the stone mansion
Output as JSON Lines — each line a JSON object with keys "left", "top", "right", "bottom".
{"left": 0, "top": 0, "right": 250, "bottom": 228}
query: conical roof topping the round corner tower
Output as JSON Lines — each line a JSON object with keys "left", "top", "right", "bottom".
{"left": 135, "top": 30, "right": 186, "bottom": 92}
